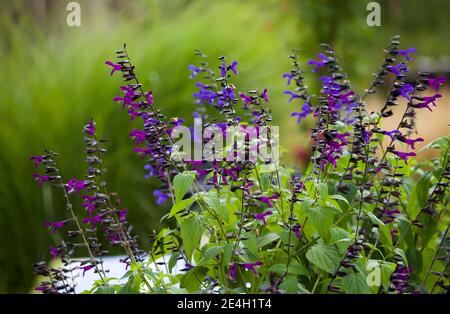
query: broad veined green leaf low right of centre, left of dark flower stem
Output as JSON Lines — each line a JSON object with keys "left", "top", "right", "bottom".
{"left": 306, "top": 244, "right": 341, "bottom": 274}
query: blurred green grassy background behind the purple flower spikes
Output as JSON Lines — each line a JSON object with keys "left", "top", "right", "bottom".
{"left": 0, "top": 0, "right": 450, "bottom": 293}
